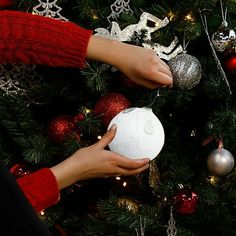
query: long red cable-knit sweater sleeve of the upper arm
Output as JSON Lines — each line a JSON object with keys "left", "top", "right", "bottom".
{"left": 0, "top": 10, "right": 92, "bottom": 68}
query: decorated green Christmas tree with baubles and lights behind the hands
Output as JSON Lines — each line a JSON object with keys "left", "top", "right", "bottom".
{"left": 0, "top": 0, "right": 236, "bottom": 236}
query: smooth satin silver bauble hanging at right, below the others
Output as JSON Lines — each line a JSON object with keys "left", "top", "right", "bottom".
{"left": 207, "top": 148, "right": 234, "bottom": 176}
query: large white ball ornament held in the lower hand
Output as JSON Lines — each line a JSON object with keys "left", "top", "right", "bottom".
{"left": 108, "top": 107, "right": 165, "bottom": 160}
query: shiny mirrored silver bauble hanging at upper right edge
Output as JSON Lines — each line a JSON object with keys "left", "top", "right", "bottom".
{"left": 211, "top": 26, "right": 236, "bottom": 52}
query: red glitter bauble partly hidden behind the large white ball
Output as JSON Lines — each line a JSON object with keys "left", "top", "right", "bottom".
{"left": 94, "top": 93, "right": 130, "bottom": 126}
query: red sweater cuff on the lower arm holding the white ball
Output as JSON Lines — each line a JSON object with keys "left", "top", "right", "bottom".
{"left": 17, "top": 168, "right": 60, "bottom": 212}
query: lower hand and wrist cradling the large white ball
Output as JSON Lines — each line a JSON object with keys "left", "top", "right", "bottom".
{"left": 51, "top": 126, "right": 149, "bottom": 189}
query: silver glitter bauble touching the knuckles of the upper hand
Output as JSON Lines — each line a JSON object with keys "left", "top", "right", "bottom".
{"left": 168, "top": 53, "right": 202, "bottom": 89}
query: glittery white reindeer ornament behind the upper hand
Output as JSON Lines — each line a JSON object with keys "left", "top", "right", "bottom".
{"left": 95, "top": 12, "right": 183, "bottom": 61}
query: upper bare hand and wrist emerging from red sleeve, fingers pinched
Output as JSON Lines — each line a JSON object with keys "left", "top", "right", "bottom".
{"left": 87, "top": 36, "right": 173, "bottom": 89}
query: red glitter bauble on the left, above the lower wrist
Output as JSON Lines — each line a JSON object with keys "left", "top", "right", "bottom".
{"left": 48, "top": 115, "right": 75, "bottom": 143}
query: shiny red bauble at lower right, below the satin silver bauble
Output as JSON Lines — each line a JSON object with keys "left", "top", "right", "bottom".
{"left": 174, "top": 188, "right": 198, "bottom": 215}
